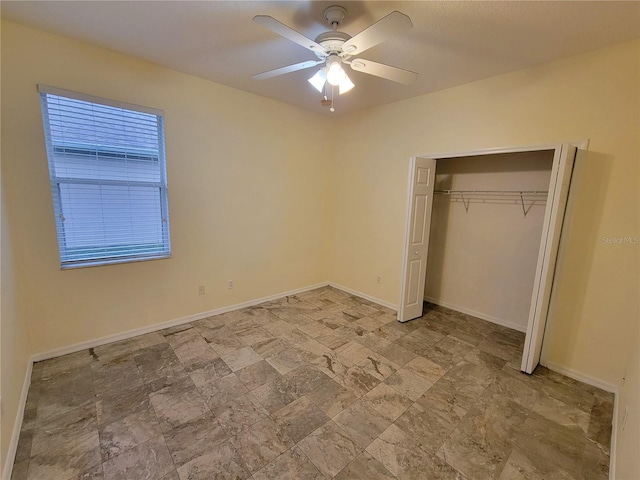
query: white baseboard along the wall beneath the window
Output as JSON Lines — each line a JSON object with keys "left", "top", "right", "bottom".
{"left": 33, "top": 282, "right": 328, "bottom": 362}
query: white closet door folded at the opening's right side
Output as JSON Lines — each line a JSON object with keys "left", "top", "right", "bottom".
{"left": 521, "top": 145, "right": 576, "bottom": 373}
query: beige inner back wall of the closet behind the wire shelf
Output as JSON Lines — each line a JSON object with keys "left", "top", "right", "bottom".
{"left": 425, "top": 150, "right": 554, "bottom": 332}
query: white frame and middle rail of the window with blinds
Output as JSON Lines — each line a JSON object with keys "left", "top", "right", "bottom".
{"left": 38, "top": 85, "right": 172, "bottom": 270}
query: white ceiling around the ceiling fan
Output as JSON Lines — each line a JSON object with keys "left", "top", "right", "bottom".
{"left": 1, "top": 0, "right": 640, "bottom": 115}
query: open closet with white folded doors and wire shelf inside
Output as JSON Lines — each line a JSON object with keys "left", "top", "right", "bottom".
{"left": 398, "top": 142, "right": 586, "bottom": 373}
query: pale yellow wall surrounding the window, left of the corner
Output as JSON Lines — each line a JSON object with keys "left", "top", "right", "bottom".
{"left": 2, "top": 18, "right": 331, "bottom": 352}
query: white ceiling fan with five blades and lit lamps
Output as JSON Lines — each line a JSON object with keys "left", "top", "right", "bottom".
{"left": 253, "top": 5, "right": 418, "bottom": 107}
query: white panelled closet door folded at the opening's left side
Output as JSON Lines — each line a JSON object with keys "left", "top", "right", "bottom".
{"left": 398, "top": 157, "right": 436, "bottom": 322}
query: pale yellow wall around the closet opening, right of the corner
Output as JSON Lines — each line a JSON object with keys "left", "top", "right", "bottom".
{"left": 330, "top": 41, "right": 640, "bottom": 384}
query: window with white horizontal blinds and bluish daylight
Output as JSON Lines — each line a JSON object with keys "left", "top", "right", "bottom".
{"left": 38, "top": 86, "right": 171, "bottom": 268}
